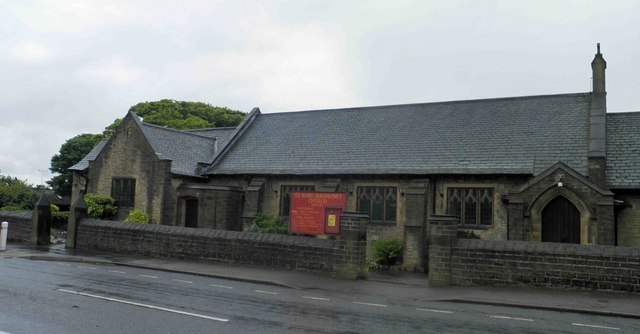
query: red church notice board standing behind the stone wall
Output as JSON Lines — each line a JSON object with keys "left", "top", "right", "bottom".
{"left": 289, "top": 191, "right": 347, "bottom": 234}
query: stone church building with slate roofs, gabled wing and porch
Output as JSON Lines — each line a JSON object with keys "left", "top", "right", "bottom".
{"left": 71, "top": 47, "right": 640, "bottom": 258}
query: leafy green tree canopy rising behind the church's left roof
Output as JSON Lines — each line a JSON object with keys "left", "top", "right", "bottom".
{"left": 129, "top": 99, "right": 245, "bottom": 130}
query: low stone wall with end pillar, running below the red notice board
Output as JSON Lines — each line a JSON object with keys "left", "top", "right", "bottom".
{"left": 75, "top": 214, "right": 368, "bottom": 279}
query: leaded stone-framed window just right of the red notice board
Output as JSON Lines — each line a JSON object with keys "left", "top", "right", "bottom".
{"left": 358, "top": 187, "right": 398, "bottom": 224}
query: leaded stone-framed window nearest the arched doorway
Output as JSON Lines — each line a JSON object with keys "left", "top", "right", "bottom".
{"left": 447, "top": 188, "right": 493, "bottom": 226}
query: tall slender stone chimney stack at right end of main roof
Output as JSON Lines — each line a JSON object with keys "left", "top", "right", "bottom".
{"left": 588, "top": 43, "right": 607, "bottom": 188}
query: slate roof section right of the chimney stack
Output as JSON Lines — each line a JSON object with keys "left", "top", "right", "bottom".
{"left": 607, "top": 112, "right": 640, "bottom": 189}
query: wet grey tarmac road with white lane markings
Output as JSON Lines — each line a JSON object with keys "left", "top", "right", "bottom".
{"left": 0, "top": 258, "right": 640, "bottom": 334}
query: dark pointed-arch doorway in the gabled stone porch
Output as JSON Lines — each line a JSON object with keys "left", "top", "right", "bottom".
{"left": 541, "top": 196, "right": 580, "bottom": 244}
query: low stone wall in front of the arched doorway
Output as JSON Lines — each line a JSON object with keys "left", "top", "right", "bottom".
{"left": 451, "top": 239, "right": 640, "bottom": 293}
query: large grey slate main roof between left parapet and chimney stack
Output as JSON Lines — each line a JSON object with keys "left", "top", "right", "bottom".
{"left": 205, "top": 93, "right": 591, "bottom": 175}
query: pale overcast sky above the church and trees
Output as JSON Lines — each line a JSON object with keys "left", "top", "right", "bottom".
{"left": 0, "top": 0, "right": 640, "bottom": 184}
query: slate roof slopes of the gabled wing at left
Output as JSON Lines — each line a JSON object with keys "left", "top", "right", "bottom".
{"left": 70, "top": 113, "right": 235, "bottom": 176}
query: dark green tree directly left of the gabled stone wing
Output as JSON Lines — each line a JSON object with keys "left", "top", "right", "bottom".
{"left": 47, "top": 133, "right": 103, "bottom": 196}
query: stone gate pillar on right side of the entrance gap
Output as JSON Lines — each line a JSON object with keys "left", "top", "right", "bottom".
{"left": 429, "top": 216, "right": 459, "bottom": 287}
